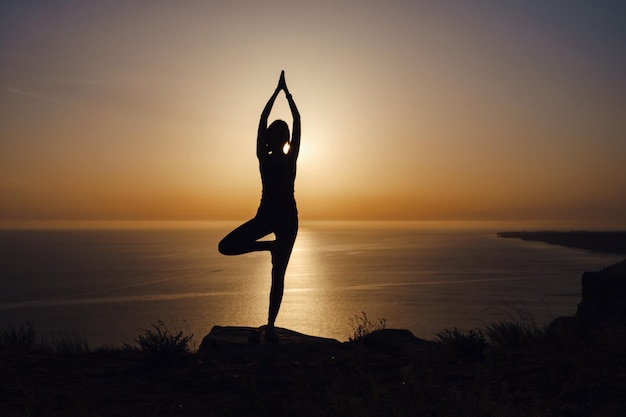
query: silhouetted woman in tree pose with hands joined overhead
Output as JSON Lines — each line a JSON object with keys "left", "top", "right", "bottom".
{"left": 218, "top": 71, "right": 300, "bottom": 341}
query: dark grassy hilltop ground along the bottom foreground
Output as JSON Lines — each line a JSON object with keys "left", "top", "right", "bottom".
{"left": 0, "top": 312, "right": 626, "bottom": 417}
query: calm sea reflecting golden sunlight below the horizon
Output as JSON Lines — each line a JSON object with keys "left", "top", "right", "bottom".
{"left": 0, "top": 222, "right": 622, "bottom": 347}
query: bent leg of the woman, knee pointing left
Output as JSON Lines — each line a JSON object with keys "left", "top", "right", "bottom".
{"left": 218, "top": 217, "right": 274, "bottom": 255}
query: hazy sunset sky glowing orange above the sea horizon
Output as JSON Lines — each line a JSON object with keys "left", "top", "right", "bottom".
{"left": 0, "top": 0, "right": 626, "bottom": 228}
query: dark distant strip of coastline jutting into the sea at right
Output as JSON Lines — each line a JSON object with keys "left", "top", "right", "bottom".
{"left": 498, "top": 231, "right": 626, "bottom": 255}
